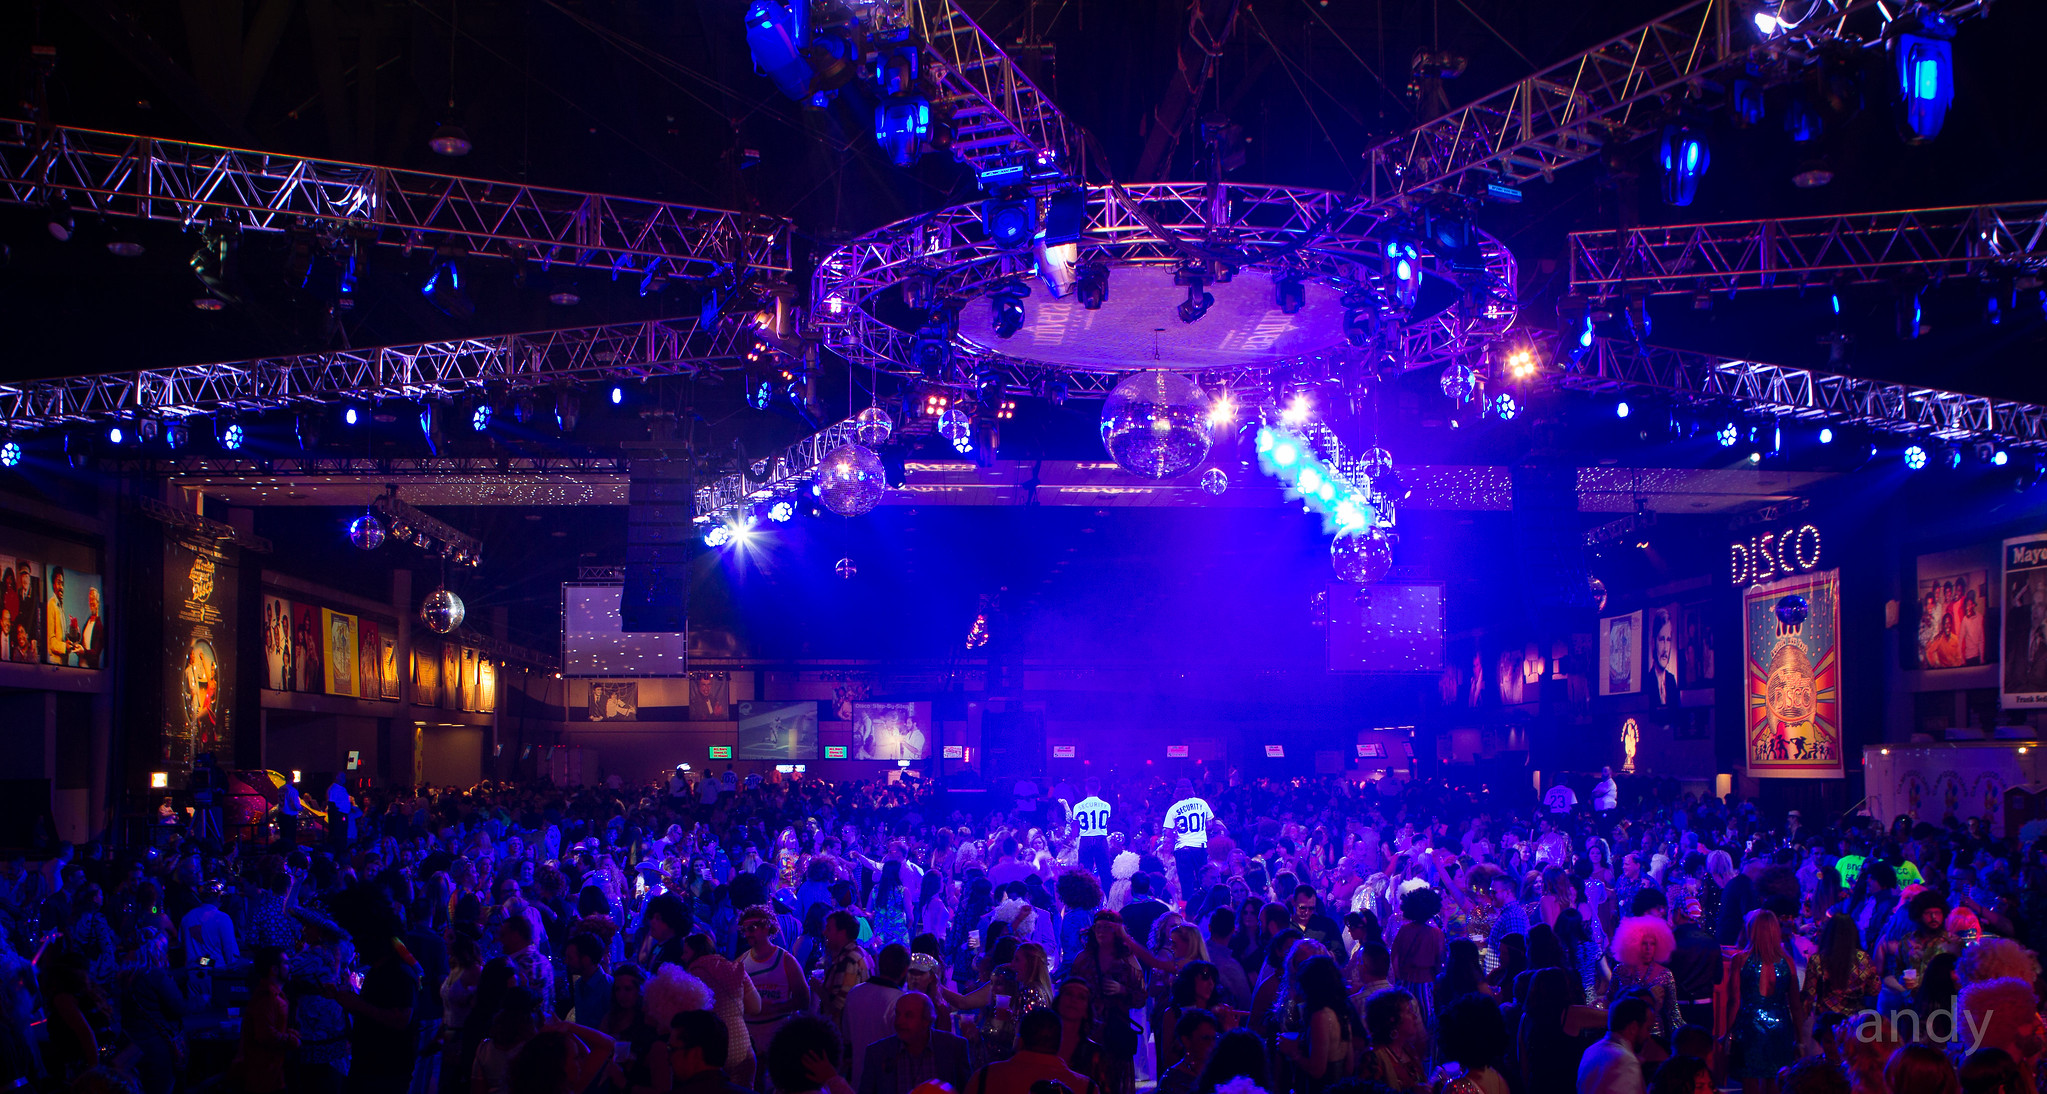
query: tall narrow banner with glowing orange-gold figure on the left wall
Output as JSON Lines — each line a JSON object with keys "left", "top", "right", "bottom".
{"left": 162, "top": 535, "right": 235, "bottom": 785}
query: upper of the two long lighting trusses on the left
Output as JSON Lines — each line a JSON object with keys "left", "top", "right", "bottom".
{"left": 0, "top": 121, "right": 790, "bottom": 277}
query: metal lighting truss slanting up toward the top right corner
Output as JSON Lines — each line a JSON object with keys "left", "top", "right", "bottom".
{"left": 1365, "top": 0, "right": 1988, "bottom": 203}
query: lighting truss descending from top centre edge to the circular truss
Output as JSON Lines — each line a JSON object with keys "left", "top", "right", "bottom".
{"left": 905, "top": 0, "right": 1083, "bottom": 178}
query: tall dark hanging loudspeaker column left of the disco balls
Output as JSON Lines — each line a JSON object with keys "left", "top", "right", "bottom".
{"left": 618, "top": 459, "right": 696, "bottom": 631}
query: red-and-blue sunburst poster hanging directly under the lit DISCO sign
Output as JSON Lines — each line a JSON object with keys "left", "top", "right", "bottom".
{"left": 1742, "top": 570, "right": 1844, "bottom": 779}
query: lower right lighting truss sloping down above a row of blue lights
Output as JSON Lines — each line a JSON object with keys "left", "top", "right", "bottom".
{"left": 1560, "top": 338, "right": 2047, "bottom": 449}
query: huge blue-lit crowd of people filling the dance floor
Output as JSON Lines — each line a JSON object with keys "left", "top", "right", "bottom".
{"left": 0, "top": 768, "right": 2047, "bottom": 1094}
